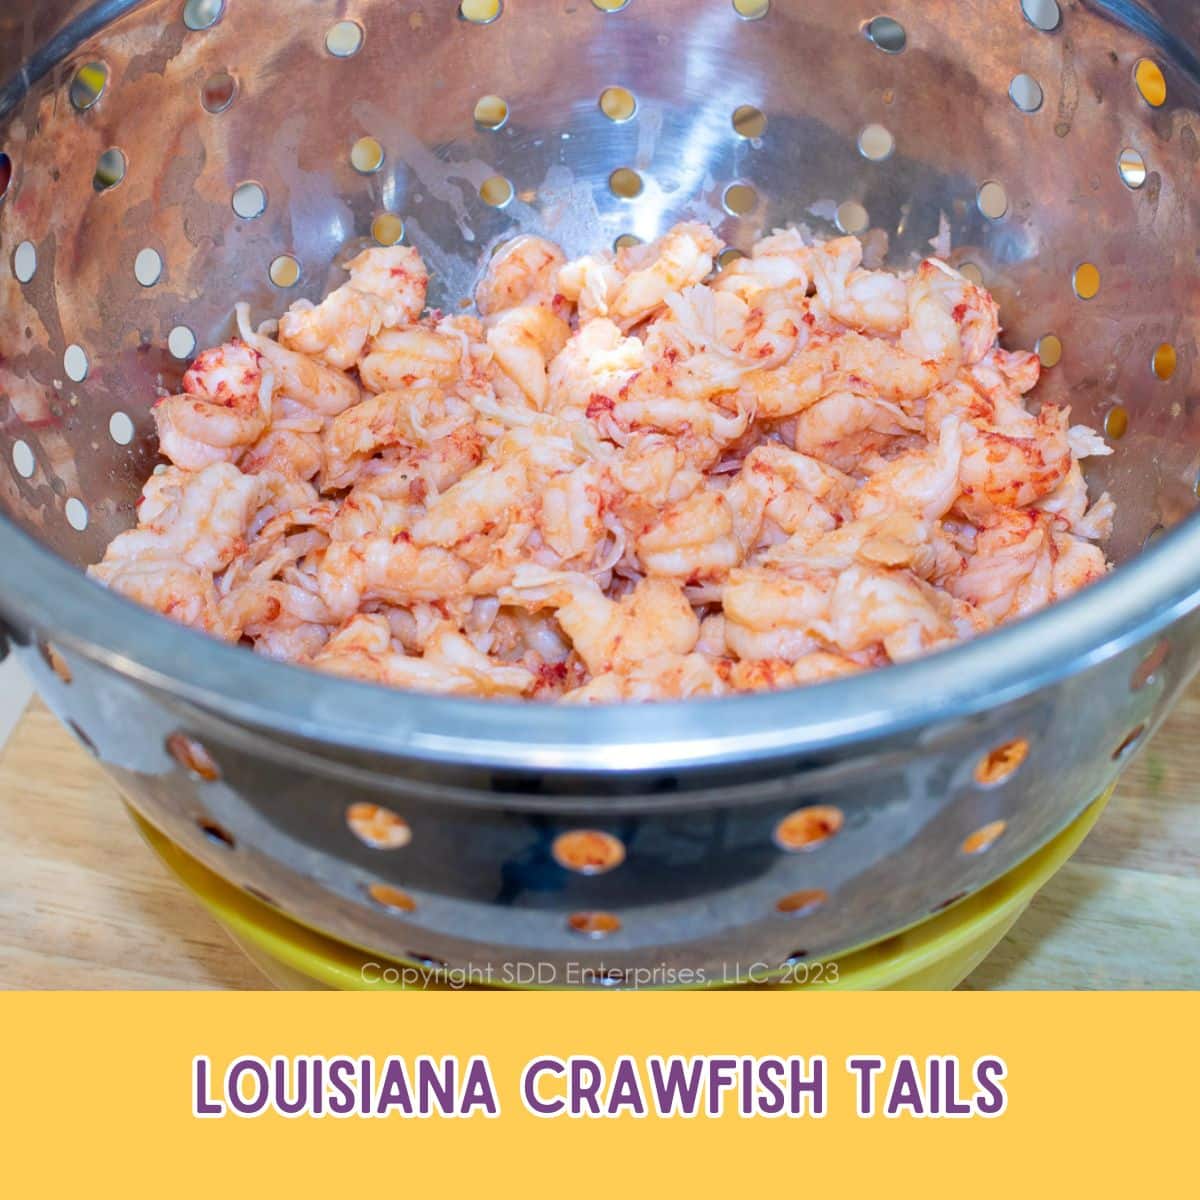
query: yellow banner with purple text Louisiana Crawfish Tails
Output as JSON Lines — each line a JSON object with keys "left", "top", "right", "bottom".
{"left": 0, "top": 992, "right": 1200, "bottom": 1200}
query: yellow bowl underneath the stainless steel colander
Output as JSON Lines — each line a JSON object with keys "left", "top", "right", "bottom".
{"left": 132, "top": 793, "right": 1111, "bottom": 991}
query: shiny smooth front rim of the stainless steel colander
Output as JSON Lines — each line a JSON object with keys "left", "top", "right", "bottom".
{"left": 0, "top": 516, "right": 1200, "bottom": 776}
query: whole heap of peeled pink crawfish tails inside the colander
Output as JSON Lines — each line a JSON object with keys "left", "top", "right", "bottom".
{"left": 90, "top": 223, "right": 1115, "bottom": 703}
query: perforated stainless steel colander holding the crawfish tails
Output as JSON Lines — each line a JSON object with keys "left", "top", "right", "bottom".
{"left": 0, "top": 0, "right": 1200, "bottom": 983}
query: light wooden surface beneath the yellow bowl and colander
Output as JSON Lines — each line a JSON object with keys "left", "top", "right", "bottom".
{"left": 0, "top": 683, "right": 1200, "bottom": 989}
